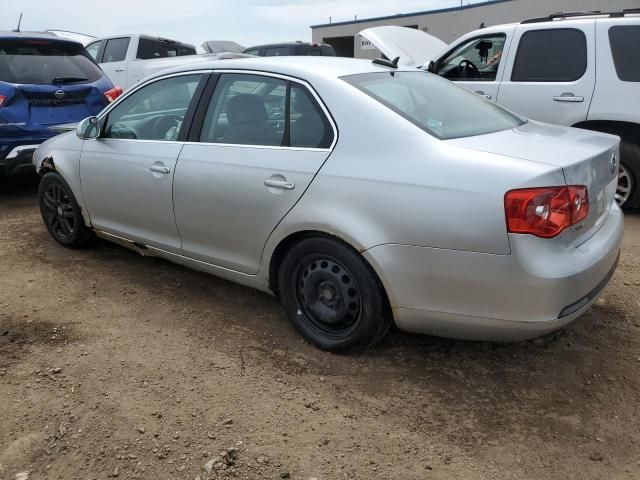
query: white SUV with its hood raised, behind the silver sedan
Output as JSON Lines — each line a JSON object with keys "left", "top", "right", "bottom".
{"left": 360, "top": 9, "right": 640, "bottom": 208}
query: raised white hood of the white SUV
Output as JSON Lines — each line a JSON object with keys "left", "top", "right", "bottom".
{"left": 358, "top": 26, "right": 447, "bottom": 67}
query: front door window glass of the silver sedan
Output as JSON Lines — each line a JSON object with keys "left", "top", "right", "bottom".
{"left": 102, "top": 74, "right": 202, "bottom": 141}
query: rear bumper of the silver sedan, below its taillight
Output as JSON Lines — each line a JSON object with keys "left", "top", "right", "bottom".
{"left": 364, "top": 206, "right": 624, "bottom": 341}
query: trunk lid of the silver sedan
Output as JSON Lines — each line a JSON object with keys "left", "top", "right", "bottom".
{"left": 448, "top": 121, "right": 620, "bottom": 246}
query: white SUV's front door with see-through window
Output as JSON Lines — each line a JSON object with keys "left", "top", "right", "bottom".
{"left": 435, "top": 32, "right": 511, "bottom": 101}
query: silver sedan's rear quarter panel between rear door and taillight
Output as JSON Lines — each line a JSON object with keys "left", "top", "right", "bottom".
{"left": 263, "top": 73, "right": 564, "bottom": 272}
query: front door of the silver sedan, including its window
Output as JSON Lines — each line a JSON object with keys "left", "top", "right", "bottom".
{"left": 80, "top": 73, "right": 206, "bottom": 253}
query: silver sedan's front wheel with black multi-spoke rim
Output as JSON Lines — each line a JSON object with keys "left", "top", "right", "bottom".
{"left": 38, "top": 172, "right": 93, "bottom": 248}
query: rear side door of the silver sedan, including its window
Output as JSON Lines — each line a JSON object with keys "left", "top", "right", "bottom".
{"left": 174, "top": 72, "right": 336, "bottom": 274}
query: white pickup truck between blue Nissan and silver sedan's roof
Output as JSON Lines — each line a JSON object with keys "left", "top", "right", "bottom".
{"left": 86, "top": 34, "right": 196, "bottom": 90}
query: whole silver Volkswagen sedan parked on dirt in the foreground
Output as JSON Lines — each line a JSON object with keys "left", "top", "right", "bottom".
{"left": 34, "top": 57, "right": 623, "bottom": 351}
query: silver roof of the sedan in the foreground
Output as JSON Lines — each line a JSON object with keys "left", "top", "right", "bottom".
{"left": 151, "top": 55, "right": 419, "bottom": 81}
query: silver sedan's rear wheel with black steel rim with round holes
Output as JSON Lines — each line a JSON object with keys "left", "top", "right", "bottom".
{"left": 278, "top": 237, "right": 393, "bottom": 352}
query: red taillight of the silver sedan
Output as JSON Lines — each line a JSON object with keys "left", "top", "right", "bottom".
{"left": 504, "top": 185, "right": 589, "bottom": 238}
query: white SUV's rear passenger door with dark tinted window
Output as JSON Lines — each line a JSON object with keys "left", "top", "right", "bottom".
{"left": 498, "top": 20, "right": 596, "bottom": 125}
